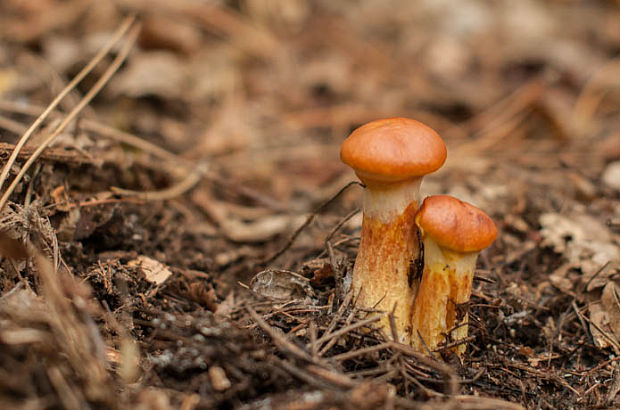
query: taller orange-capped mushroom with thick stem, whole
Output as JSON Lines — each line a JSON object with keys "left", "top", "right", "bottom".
{"left": 340, "top": 118, "right": 446, "bottom": 343}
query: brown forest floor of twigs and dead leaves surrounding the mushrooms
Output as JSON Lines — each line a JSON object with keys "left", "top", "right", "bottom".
{"left": 0, "top": 0, "right": 620, "bottom": 410}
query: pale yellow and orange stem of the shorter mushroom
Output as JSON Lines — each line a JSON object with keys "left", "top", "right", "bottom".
{"left": 411, "top": 237, "right": 478, "bottom": 355}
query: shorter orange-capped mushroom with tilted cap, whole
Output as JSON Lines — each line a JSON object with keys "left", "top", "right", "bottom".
{"left": 411, "top": 195, "right": 497, "bottom": 355}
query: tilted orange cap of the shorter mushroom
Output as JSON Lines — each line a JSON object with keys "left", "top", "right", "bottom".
{"left": 415, "top": 195, "right": 497, "bottom": 253}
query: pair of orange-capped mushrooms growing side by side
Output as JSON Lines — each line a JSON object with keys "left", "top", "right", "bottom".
{"left": 340, "top": 118, "right": 497, "bottom": 354}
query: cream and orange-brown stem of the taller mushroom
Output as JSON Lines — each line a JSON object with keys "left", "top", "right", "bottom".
{"left": 351, "top": 177, "right": 422, "bottom": 343}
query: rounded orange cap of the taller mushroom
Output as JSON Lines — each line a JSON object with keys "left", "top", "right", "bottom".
{"left": 340, "top": 118, "right": 446, "bottom": 183}
